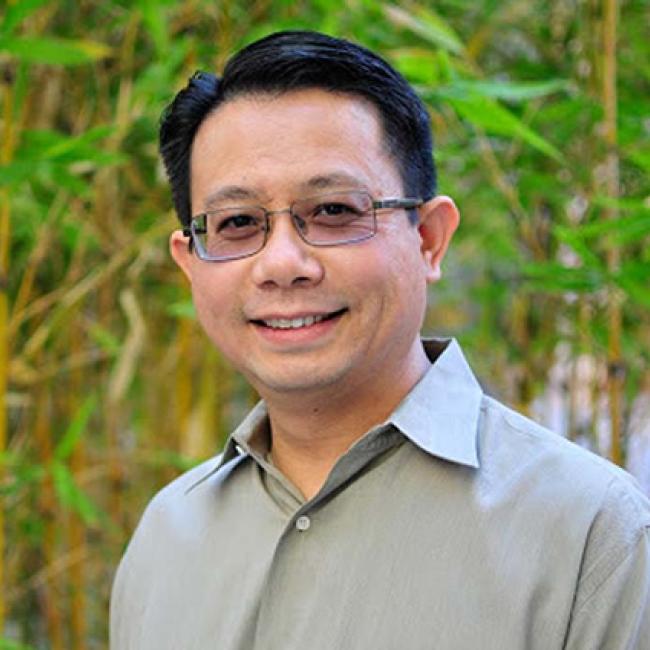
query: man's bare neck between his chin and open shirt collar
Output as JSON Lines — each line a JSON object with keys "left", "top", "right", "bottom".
{"left": 263, "top": 346, "right": 430, "bottom": 499}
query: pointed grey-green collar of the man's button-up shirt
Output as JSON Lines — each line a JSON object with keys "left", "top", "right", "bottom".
{"left": 217, "top": 339, "right": 483, "bottom": 469}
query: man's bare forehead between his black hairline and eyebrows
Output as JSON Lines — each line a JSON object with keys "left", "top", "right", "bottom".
{"left": 191, "top": 90, "right": 401, "bottom": 208}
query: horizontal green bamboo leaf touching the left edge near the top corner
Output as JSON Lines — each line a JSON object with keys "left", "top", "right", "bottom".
{"left": 0, "top": 36, "right": 112, "bottom": 65}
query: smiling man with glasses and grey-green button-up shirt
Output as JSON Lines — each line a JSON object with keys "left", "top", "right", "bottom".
{"left": 111, "top": 32, "right": 650, "bottom": 650}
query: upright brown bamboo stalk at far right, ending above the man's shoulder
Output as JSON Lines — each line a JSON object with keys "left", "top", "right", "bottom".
{"left": 603, "top": 0, "right": 625, "bottom": 465}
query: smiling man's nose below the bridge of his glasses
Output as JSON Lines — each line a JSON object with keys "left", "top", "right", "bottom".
{"left": 252, "top": 210, "right": 324, "bottom": 289}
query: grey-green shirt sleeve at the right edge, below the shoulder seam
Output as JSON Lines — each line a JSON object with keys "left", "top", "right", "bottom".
{"left": 565, "top": 474, "right": 650, "bottom": 650}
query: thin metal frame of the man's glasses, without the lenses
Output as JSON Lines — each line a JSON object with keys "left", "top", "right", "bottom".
{"left": 182, "top": 190, "right": 424, "bottom": 262}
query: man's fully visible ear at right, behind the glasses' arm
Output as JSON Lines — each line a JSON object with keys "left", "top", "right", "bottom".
{"left": 418, "top": 196, "right": 460, "bottom": 282}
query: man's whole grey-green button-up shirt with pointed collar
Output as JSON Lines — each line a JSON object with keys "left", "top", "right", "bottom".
{"left": 111, "top": 341, "right": 650, "bottom": 650}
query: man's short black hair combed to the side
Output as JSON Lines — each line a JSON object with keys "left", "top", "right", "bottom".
{"left": 160, "top": 31, "right": 436, "bottom": 225}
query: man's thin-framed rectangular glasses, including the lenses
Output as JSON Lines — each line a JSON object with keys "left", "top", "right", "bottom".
{"left": 183, "top": 190, "right": 422, "bottom": 262}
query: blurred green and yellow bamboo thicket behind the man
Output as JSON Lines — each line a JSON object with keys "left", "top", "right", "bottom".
{"left": 0, "top": 0, "right": 650, "bottom": 650}
